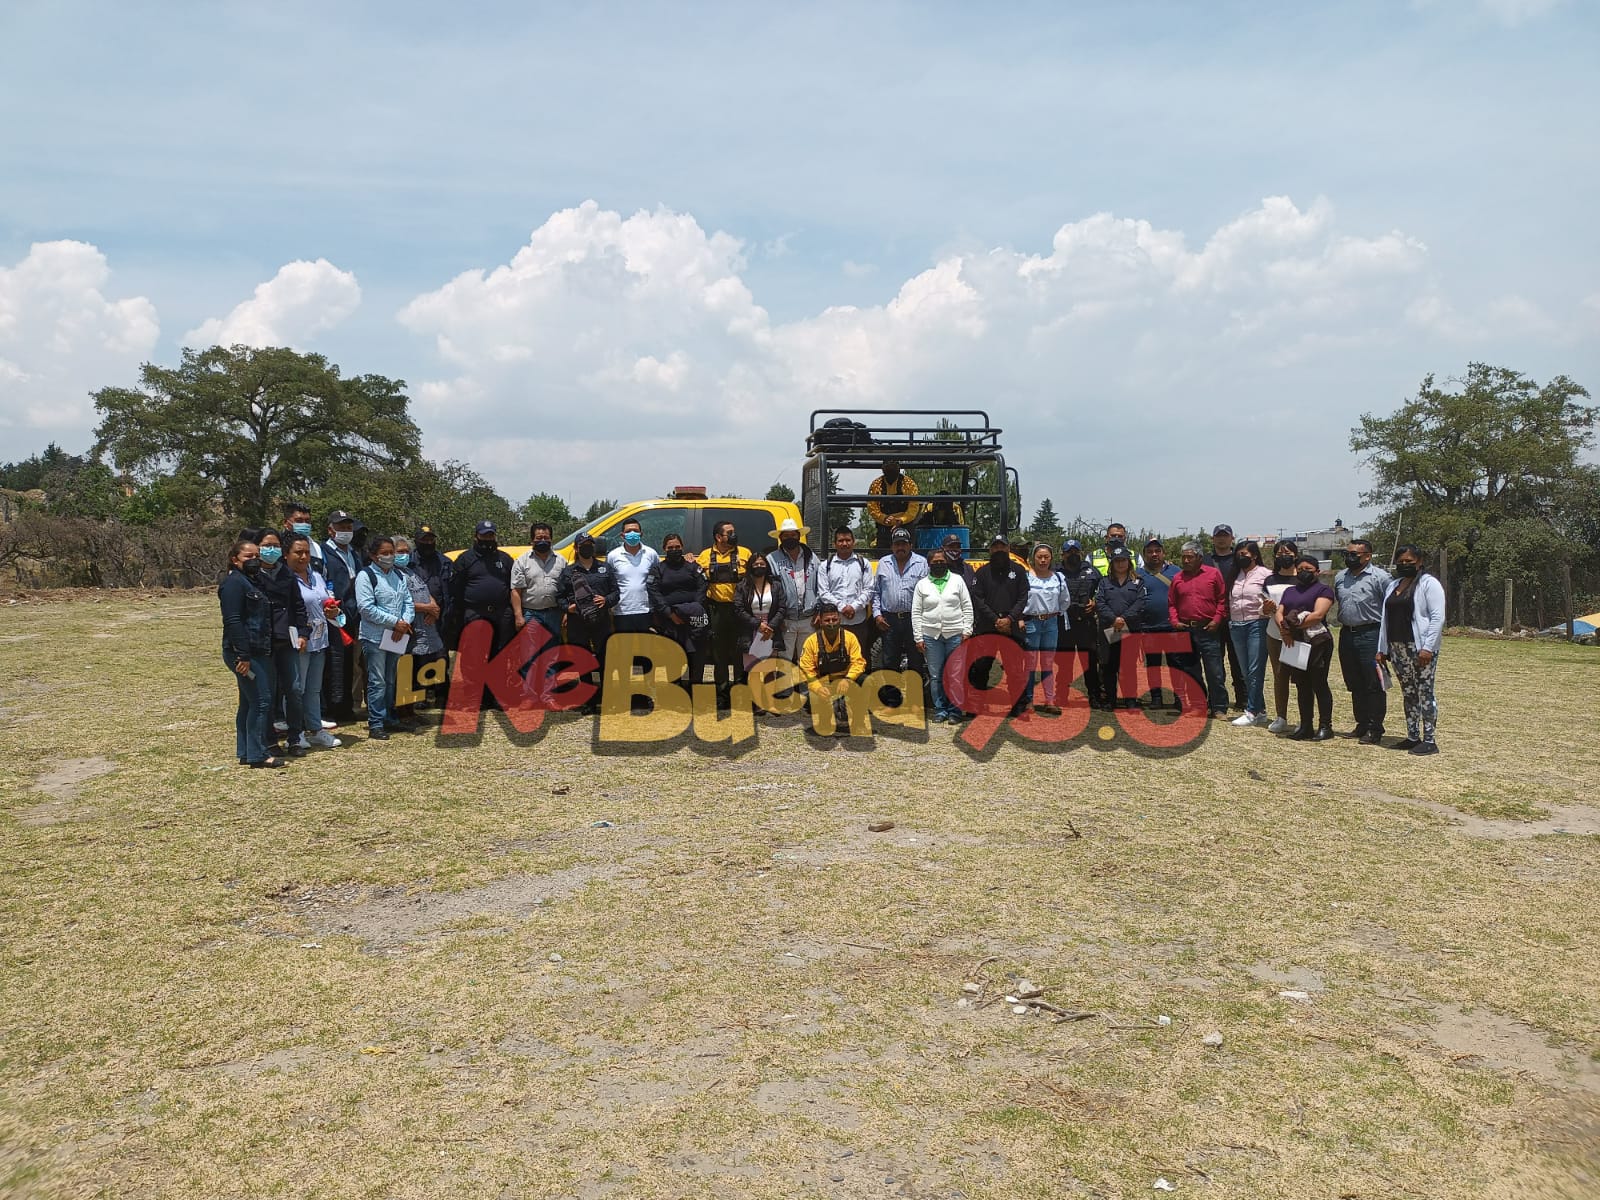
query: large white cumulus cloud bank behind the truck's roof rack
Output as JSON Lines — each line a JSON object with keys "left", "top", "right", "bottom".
{"left": 390, "top": 197, "right": 1574, "bottom": 528}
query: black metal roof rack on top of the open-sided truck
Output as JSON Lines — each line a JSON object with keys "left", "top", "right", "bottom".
{"left": 805, "top": 408, "right": 1000, "bottom": 470}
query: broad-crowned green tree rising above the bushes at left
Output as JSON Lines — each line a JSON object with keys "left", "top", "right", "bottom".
{"left": 94, "top": 346, "right": 421, "bottom": 522}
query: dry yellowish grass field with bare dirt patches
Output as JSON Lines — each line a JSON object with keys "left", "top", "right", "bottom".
{"left": 0, "top": 594, "right": 1600, "bottom": 1200}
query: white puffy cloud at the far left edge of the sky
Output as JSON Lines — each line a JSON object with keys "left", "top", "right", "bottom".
{"left": 0, "top": 242, "right": 160, "bottom": 453}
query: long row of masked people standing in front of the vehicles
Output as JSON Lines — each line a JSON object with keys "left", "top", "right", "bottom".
{"left": 218, "top": 493, "right": 1445, "bottom": 766}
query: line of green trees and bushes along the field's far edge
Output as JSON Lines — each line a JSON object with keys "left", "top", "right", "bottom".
{"left": 0, "top": 346, "right": 1600, "bottom": 626}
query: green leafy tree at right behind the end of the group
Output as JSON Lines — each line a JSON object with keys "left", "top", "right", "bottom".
{"left": 1350, "top": 363, "right": 1600, "bottom": 626}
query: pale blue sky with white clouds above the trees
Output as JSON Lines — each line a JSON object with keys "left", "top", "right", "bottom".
{"left": 0, "top": 0, "right": 1600, "bottom": 531}
